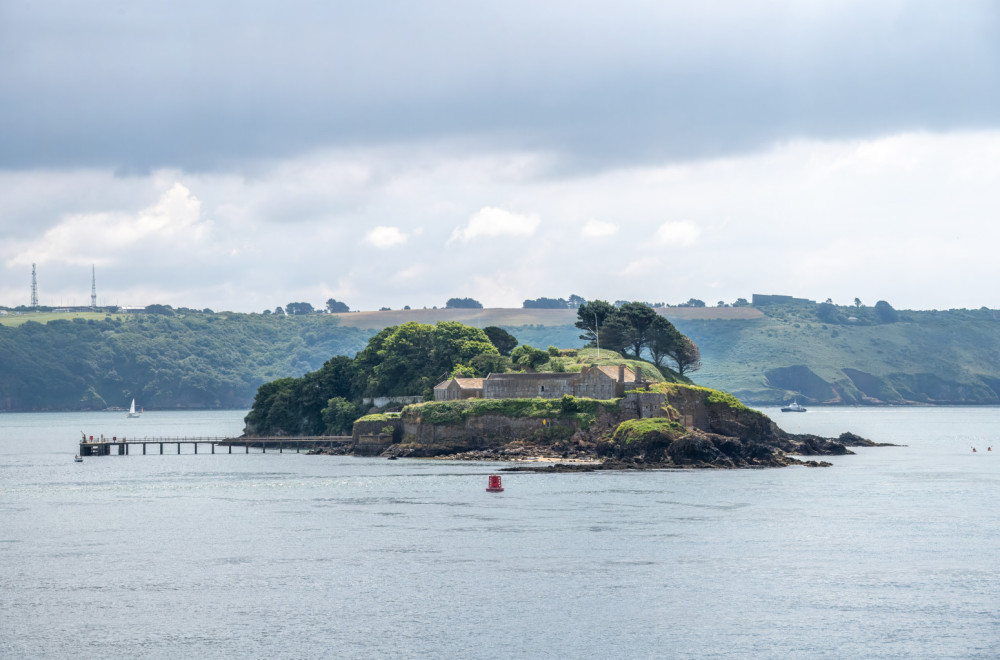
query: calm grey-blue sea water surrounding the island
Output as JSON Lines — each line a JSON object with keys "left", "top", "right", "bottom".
{"left": 0, "top": 408, "right": 1000, "bottom": 658}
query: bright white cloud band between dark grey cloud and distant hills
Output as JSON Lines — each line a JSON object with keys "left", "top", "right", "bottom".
{"left": 9, "top": 131, "right": 1000, "bottom": 311}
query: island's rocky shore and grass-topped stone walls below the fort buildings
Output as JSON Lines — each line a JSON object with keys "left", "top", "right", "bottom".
{"left": 355, "top": 384, "right": 888, "bottom": 469}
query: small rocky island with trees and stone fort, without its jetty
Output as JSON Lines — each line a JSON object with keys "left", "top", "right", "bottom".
{"left": 238, "top": 301, "right": 888, "bottom": 470}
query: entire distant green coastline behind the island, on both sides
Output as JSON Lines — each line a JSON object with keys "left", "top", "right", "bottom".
{"left": 7, "top": 304, "right": 1000, "bottom": 411}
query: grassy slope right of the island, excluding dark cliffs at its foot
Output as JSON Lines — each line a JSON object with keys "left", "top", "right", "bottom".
{"left": 676, "top": 308, "right": 1000, "bottom": 403}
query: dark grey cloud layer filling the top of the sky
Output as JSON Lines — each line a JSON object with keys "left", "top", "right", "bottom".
{"left": 0, "top": 1, "right": 1000, "bottom": 172}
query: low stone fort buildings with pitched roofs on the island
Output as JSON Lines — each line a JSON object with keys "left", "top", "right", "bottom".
{"left": 434, "top": 365, "right": 645, "bottom": 401}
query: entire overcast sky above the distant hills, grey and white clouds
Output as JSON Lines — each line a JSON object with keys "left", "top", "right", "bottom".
{"left": 0, "top": 0, "right": 1000, "bottom": 311}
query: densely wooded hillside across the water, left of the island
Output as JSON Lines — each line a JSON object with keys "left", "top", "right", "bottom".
{"left": 0, "top": 310, "right": 371, "bottom": 411}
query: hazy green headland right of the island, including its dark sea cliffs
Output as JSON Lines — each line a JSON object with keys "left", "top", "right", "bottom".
{"left": 675, "top": 306, "right": 1000, "bottom": 404}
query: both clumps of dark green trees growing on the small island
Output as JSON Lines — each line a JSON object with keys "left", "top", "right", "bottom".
{"left": 246, "top": 300, "right": 698, "bottom": 435}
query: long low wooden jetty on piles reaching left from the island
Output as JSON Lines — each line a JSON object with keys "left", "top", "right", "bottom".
{"left": 80, "top": 435, "right": 352, "bottom": 456}
